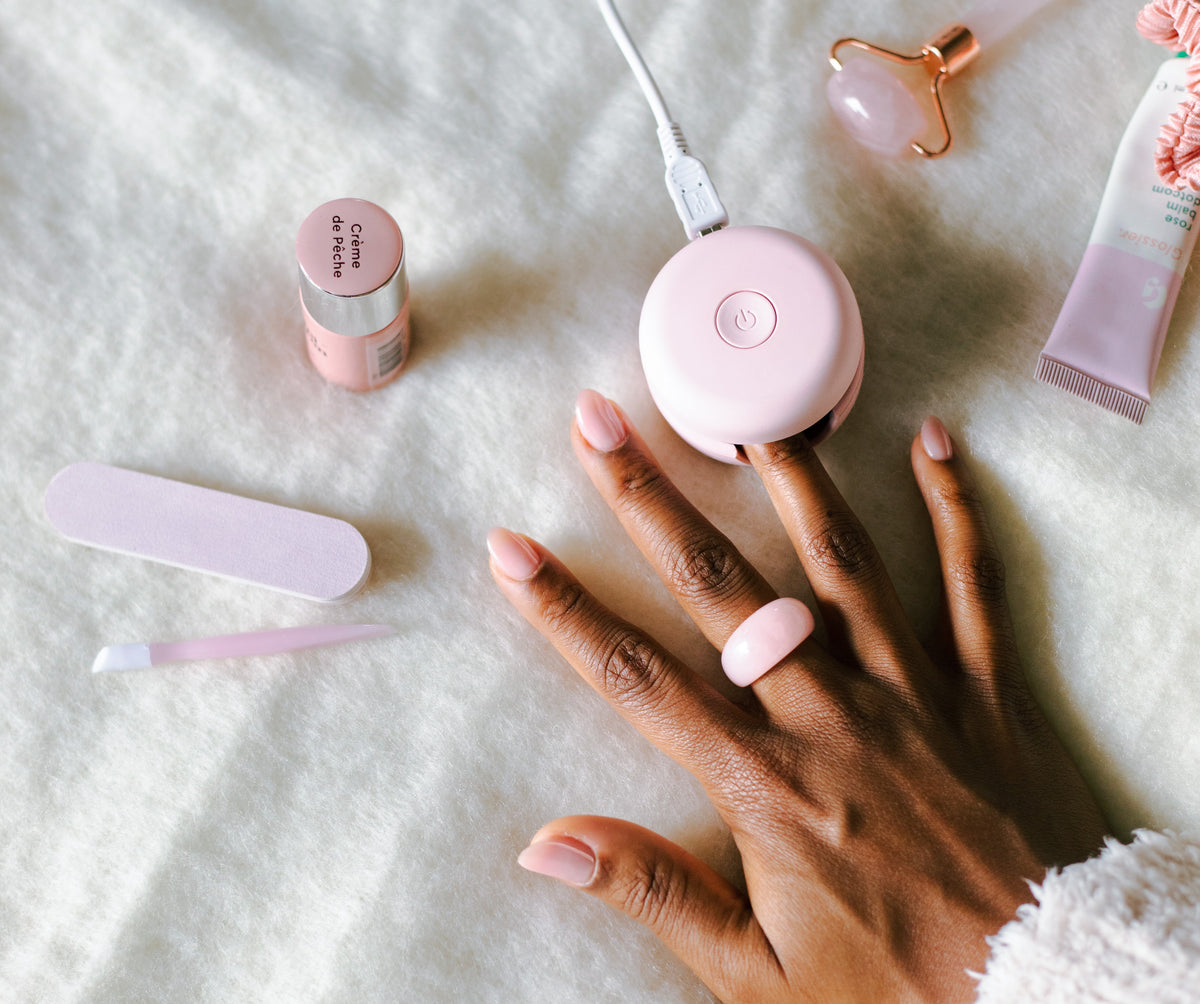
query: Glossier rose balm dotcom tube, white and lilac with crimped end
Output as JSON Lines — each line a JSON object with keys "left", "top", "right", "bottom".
{"left": 1037, "top": 59, "right": 1200, "bottom": 422}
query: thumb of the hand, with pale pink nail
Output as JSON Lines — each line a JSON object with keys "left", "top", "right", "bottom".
{"left": 517, "top": 816, "right": 782, "bottom": 1000}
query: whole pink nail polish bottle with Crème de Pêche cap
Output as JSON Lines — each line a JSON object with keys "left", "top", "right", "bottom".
{"left": 296, "top": 199, "right": 408, "bottom": 391}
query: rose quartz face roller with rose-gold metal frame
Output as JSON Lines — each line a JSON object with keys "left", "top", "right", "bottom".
{"left": 827, "top": 0, "right": 1051, "bottom": 157}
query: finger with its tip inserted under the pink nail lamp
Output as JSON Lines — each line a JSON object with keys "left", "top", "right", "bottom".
{"left": 745, "top": 435, "right": 920, "bottom": 683}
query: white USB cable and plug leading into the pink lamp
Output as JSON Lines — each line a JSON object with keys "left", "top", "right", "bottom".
{"left": 596, "top": 0, "right": 730, "bottom": 240}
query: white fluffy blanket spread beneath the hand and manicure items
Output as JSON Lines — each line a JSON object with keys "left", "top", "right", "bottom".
{"left": 0, "top": 0, "right": 1200, "bottom": 1004}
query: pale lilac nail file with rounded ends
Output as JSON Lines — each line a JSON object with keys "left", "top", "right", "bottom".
{"left": 46, "top": 462, "right": 371, "bottom": 602}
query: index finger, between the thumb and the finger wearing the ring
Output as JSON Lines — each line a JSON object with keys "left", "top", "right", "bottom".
{"left": 487, "top": 528, "right": 749, "bottom": 782}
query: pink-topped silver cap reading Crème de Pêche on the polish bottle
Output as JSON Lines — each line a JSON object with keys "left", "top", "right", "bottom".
{"left": 296, "top": 199, "right": 408, "bottom": 337}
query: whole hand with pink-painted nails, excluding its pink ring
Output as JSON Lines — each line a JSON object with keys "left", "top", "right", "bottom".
{"left": 488, "top": 391, "right": 1106, "bottom": 1002}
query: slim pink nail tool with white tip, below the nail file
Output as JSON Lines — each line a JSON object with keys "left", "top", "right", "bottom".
{"left": 91, "top": 624, "right": 395, "bottom": 673}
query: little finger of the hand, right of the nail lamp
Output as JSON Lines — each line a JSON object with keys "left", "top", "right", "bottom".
{"left": 912, "top": 419, "right": 1025, "bottom": 690}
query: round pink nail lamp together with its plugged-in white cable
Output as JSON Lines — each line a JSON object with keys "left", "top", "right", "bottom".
{"left": 598, "top": 0, "right": 864, "bottom": 463}
